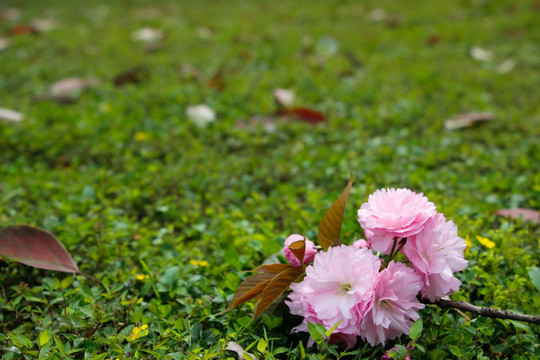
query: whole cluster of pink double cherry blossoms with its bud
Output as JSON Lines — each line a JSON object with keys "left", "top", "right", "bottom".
{"left": 284, "top": 189, "right": 467, "bottom": 347}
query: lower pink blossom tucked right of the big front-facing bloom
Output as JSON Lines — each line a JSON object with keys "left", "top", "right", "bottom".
{"left": 360, "top": 261, "right": 424, "bottom": 346}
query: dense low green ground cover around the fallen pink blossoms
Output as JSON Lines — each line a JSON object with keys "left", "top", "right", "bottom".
{"left": 0, "top": 0, "right": 540, "bottom": 359}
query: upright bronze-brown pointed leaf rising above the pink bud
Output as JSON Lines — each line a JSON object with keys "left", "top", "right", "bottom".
{"left": 318, "top": 173, "right": 354, "bottom": 250}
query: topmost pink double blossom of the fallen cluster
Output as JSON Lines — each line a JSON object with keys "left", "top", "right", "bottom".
{"left": 358, "top": 189, "right": 437, "bottom": 254}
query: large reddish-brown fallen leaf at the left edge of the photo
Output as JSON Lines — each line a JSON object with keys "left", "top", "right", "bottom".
{"left": 0, "top": 225, "right": 80, "bottom": 273}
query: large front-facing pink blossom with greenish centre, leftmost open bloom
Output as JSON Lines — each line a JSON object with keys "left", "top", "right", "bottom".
{"left": 285, "top": 245, "right": 381, "bottom": 344}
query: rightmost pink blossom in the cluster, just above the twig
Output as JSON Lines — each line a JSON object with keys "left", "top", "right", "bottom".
{"left": 402, "top": 214, "right": 468, "bottom": 301}
